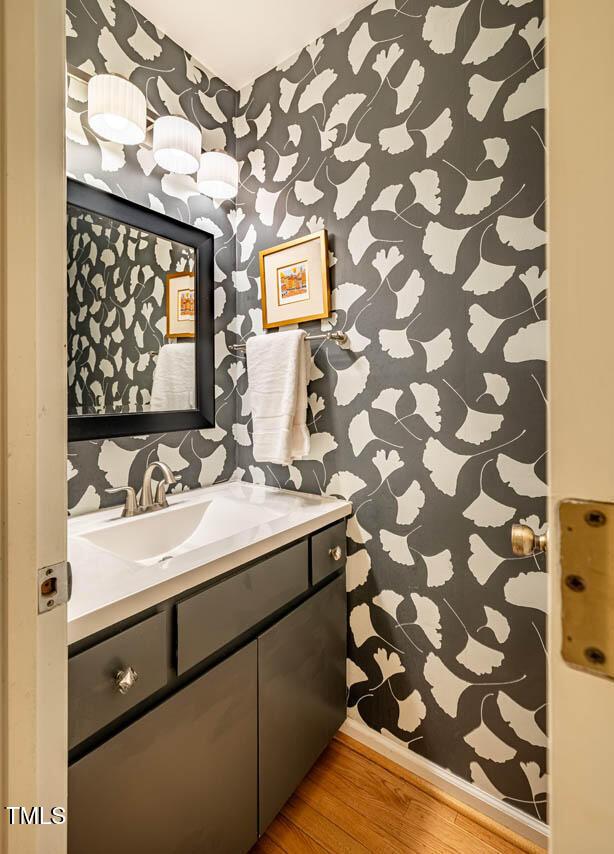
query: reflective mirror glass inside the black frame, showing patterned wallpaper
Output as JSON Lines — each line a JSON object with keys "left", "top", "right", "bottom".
{"left": 67, "top": 204, "right": 197, "bottom": 422}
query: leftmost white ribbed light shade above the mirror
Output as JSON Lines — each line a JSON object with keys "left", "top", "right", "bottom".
{"left": 87, "top": 74, "right": 147, "bottom": 145}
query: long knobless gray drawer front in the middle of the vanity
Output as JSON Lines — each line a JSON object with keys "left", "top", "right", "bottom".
{"left": 177, "top": 542, "right": 309, "bottom": 674}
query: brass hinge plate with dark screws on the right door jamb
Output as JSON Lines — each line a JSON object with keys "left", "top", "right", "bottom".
{"left": 559, "top": 500, "right": 614, "bottom": 678}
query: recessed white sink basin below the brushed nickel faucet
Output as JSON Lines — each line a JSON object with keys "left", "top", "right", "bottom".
{"left": 80, "top": 498, "right": 282, "bottom": 565}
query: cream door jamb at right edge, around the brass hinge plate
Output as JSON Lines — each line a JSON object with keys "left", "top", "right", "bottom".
{"left": 547, "top": 0, "right": 614, "bottom": 854}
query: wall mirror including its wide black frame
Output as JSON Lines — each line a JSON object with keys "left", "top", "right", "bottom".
{"left": 67, "top": 179, "right": 215, "bottom": 441}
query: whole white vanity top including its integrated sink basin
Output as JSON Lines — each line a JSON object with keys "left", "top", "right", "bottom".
{"left": 68, "top": 481, "right": 352, "bottom": 643}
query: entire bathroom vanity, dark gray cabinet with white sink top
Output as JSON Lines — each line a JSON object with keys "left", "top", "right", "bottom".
{"left": 68, "top": 484, "right": 351, "bottom": 854}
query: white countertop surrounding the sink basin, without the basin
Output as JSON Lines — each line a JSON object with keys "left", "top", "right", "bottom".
{"left": 68, "top": 482, "right": 352, "bottom": 643}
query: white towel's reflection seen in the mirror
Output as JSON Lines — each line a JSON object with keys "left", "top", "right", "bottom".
{"left": 150, "top": 344, "right": 196, "bottom": 412}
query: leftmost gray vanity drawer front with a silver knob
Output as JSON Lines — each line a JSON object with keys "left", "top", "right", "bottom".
{"left": 68, "top": 614, "right": 169, "bottom": 748}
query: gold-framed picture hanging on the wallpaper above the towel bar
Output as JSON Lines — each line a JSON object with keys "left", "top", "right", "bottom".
{"left": 260, "top": 229, "right": 330, "bottom": 329}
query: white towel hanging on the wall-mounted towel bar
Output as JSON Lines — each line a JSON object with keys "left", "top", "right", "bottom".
{"left": 247, "top": 330, "right": 311, "bottom": 465}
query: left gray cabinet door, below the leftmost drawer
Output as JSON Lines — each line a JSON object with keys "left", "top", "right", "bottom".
{"left": 68, "top": 641, "right": 257, "bottom": 854}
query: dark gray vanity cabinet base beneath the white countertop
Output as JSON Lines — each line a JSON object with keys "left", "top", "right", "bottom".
{"left": 68, "top": 522, "right": 347, "bottom": 854}
